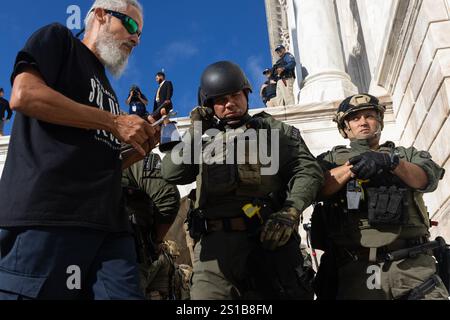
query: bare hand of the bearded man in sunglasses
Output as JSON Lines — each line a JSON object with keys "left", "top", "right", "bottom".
{"left": 112, "top": 115, "right": 159, "bottom": 156}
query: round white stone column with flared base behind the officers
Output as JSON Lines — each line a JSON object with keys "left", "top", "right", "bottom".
{"left": 294, "top": 0, "right": 358, "bottom": 104}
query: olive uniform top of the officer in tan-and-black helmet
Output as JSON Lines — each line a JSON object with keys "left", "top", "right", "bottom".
{"left": 318, "top": 140, "right": 445, "bottom": 248}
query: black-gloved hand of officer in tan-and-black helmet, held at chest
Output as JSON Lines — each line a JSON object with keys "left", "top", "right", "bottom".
{"left": 349, "top": 151, "right": 393, "bottom": 180}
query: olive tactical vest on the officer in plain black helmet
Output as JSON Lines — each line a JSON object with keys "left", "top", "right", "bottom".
{"left": 196, "top": 117, "right": 282, "bottom": 219}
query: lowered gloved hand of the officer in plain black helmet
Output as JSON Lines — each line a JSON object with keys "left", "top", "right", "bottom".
{"left": 260, "top": 207, "right": 300, "bottom": 251}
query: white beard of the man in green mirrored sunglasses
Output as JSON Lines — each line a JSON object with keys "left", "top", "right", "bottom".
{"left": 95, "top": 31, "right": 130, "bottom": 78}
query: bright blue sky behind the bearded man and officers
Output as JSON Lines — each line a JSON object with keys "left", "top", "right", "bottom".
{"left": 0, "top": 0, "right": 271, "bottom": 134}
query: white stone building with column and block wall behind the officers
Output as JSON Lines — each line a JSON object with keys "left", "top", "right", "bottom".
{"left": 0, "top": 0, "right": 450, "bottom": 241}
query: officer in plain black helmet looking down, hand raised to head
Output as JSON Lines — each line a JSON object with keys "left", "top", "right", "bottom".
{"left": 162, "top": 61, "right": 323, "bottom": 300}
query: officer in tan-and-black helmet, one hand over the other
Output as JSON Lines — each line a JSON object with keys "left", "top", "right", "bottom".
{"left": 312, "top": 94, "right": 448, "bottom": 300}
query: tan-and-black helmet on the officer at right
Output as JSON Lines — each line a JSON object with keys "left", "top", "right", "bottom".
{"left": 333, "top": 93, "right": 386, "bottom": 138}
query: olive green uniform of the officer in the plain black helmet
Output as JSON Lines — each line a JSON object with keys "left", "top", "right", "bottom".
{"left": 162, "top": 112, "right": 323, "bottom": 300}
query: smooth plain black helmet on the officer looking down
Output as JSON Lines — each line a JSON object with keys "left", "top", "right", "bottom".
{"left": 199, "top": 61, "right": 252, "bottom": 107}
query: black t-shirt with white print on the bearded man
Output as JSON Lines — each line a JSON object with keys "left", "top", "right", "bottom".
{"left": 0, "top": 24, "right": 128, "bottom": 232}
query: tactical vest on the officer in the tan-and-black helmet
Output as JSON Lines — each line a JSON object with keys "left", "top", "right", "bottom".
{"left": 324, "top": 142, "right": 430, "bottom": 248}
